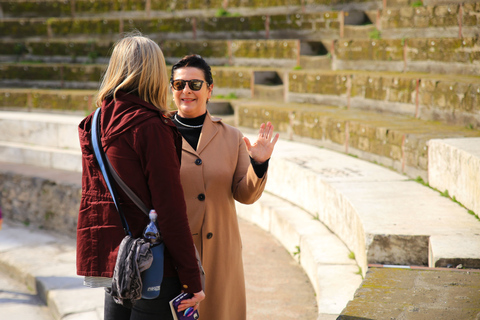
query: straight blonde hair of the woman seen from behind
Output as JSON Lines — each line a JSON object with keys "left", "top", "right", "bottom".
{"left": 95, "top": 32, "right": 168, "bottom": 113}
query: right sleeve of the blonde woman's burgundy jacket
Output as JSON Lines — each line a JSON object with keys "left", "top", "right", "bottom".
{"left": 135, "top": 122, "right": 202, "bottom": 293}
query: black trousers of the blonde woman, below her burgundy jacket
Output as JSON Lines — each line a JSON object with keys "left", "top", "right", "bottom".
{"left": 104, "top": 278, "right": 182, "bottom": 320}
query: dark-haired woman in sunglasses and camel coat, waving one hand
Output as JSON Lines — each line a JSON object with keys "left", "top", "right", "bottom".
{"left": 170, "top": 55, "right": 278, "bottom": 320}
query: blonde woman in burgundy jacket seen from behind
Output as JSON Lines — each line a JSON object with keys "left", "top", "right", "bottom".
{"left": 77, "top": 33, "right": 205, "bottom": 320}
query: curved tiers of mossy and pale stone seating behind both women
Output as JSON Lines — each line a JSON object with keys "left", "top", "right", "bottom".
{"left": 0, "top": 0, "right": 480, "bottom": 314}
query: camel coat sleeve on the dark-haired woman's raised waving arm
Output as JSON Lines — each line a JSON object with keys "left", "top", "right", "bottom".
{"left": 232, "top": 132, "right": 267, "bottom": 204}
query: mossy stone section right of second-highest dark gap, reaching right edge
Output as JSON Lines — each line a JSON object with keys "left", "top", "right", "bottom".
{"left": 331, "top": 36, "right": 480, "bottom": 76}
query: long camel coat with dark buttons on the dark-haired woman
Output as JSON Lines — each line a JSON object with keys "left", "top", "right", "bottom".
{"left": 180, "top": 114, "right": 267, "bottom": 320}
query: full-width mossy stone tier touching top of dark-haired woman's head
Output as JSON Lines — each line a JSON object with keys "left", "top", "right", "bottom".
{"left": 0, "top": 35, "right": 480, "bottom": 75}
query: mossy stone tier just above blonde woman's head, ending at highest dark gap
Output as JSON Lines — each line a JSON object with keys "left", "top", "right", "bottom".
{"left": 0, "top": 11, "right": 343, "bottom": 41}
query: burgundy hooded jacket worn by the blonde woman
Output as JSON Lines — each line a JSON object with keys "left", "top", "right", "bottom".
{"left": 77, "top": 92, "right": 202, "bottom": 293}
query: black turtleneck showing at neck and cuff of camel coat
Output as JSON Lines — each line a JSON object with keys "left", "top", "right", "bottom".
{"left": 172, "top": 112, "right": 270, "bottom": 179}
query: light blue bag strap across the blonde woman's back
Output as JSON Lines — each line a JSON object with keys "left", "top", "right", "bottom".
{"left": 92, "top": 108, "right": 131, "bottom": 235}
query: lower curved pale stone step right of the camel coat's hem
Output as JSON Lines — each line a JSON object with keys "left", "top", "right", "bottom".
{"left": 236, "top": 193, "right": 362, "bottom": 314}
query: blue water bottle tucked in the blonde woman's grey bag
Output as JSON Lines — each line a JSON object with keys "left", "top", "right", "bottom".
{"left": 142, "top": 210, "right": 165, "bottom": 299}
